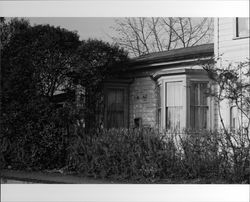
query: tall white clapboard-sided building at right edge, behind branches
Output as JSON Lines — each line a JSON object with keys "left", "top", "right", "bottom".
{"left": 214, "top": 18, "right": 250, "bottom": 129}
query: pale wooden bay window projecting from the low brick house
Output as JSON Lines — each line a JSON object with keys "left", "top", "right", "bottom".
{"left": 158, "top": 70, "right": 212, "bottom": 131}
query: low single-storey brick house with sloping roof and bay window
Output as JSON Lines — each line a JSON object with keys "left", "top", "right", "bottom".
{"left": 104, "top": 44, "right": 218, "bottom": 130}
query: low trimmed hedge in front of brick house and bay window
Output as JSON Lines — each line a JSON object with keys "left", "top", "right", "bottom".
{"left": 68, "top": 129, "right": 249, "bottom": 183}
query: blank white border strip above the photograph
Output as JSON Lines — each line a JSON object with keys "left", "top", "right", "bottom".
{"left": 0, "top": 0, "right": 249, "bottom": 17}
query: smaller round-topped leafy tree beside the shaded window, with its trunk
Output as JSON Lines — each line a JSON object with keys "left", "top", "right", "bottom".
{"left": 71, "top": 39, "right": 128, "bottom": 129}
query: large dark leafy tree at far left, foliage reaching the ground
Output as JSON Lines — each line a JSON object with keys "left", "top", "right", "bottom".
{"left": 1, "top": 20, "right": 80, "bottom": 167}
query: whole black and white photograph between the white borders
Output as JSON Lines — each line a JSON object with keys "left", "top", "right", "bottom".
{"left": 0, "top": 0, "right": 250, "bottom": 202}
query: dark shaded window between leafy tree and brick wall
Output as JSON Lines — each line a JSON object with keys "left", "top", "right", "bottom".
{"left": 106, "top": 88, "right": 125, "bottom": 128}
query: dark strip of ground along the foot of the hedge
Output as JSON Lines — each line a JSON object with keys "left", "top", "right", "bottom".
{"left": 1, "top": 170, "right": 227, "bottom": 184}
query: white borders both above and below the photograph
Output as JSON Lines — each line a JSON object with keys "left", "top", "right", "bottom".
{"left": 0, "top": 0, "right": 250, "bottom": 202}
